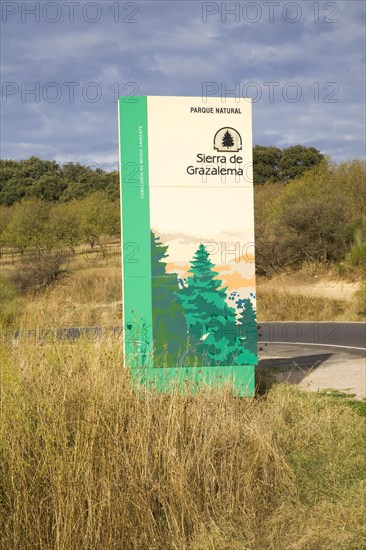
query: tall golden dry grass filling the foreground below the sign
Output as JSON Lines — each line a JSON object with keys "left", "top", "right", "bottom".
{"left": 0, "top": 336, "right": 366, "bottom": 550}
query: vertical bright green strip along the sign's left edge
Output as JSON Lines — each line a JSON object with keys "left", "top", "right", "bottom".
{"left": 119, "top": 97, "right": 152, "bottom": 368}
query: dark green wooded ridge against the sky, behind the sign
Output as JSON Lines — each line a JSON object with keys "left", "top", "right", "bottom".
{"left": 0, "top": 145, "right": 324, "bottom": 206}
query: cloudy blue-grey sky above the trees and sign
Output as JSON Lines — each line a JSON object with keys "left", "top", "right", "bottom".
{"left": 1, "top": 0, "right": 365, "bottom": 168}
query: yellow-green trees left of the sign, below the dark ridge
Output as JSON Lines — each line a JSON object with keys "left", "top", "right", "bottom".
{"left": 0, "top": 191, "right": 120, "bottom": 296}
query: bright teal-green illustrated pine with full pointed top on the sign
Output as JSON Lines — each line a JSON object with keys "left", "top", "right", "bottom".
{"left": 177, "top": 244, "right": 242, "bottom": 366}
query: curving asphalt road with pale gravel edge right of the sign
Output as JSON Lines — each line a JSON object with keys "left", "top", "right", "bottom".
{"left": 256, "top": 322, "right": 366, "bottom": 399}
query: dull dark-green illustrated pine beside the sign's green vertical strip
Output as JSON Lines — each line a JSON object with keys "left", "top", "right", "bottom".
{"left": 151, "top": 232, "right": 187, "bottom": 367}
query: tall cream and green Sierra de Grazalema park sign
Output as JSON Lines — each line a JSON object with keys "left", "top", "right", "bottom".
{"left": 119, "top": 96, "right": 257, "bottom": 395}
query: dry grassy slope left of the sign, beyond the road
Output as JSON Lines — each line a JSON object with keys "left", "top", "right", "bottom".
{"left": 0, "top": 243, "right": 122, "bottom": 330}
